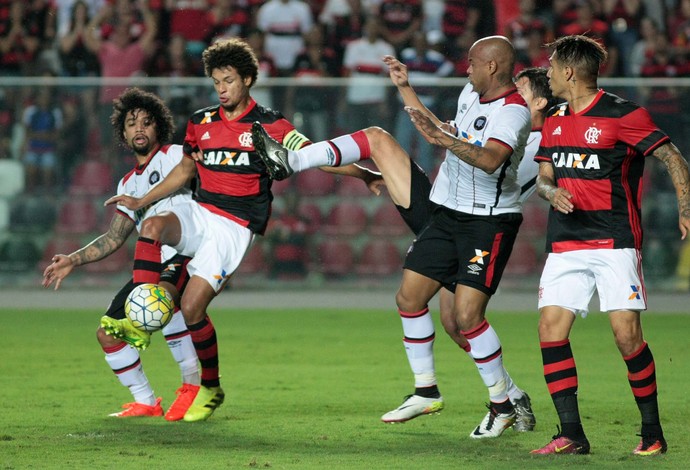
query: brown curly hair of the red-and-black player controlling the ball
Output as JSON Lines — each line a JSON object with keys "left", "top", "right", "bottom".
{"left": 201, "top": 38, "right": 259, "bottom": 88}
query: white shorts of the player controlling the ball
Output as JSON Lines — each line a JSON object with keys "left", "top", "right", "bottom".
{"left": 170, "top": 203, "right": 254, "bottom": 292}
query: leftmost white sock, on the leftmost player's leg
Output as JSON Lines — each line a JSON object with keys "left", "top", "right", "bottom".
{"left": 104, "top": 342, "right": 156, "bottom": 406}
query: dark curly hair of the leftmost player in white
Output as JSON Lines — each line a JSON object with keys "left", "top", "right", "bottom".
{"left": 110, "top": 87, "right": 175, "bottom": 144}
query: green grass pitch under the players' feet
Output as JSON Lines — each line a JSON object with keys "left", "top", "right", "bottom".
{"left": 0, "top": 309, "right": 690, "bottom": 469}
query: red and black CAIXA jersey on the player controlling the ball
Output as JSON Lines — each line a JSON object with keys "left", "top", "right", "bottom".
{"left": 184, "top": 100, "right": 295, "bottom": 234}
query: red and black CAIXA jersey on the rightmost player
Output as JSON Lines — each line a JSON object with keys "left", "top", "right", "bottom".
{"left": 534, "top": 90, "right": 669, "bottom": 253}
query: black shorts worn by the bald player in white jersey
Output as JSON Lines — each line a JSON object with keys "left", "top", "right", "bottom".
{"left": 404, "top": 207, "right": 522, "bottom": 296}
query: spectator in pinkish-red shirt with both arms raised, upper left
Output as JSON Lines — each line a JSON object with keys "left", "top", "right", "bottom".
{"left": 85, "top": 0, "right": 158, "bottom": 163}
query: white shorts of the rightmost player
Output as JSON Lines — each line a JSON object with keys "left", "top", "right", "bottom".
{"left": 539, "top": 248, "right": 647, "bottom": 317}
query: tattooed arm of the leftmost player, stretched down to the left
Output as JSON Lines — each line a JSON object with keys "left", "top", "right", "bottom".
{"left": 43, "top": 213, "right": 134, "bottom": 290}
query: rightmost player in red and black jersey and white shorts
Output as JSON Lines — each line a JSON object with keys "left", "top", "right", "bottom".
{"left": 532, "top": 36, "right": 690, "bottom": 456}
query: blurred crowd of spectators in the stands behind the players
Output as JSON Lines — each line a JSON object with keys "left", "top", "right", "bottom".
{"left": 0, "top": 0, "right": 690, "bottom": 284}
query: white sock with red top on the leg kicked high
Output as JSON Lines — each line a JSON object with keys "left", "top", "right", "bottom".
{"left": 288, "top": 131, "right": 371, "bottom": 172}
